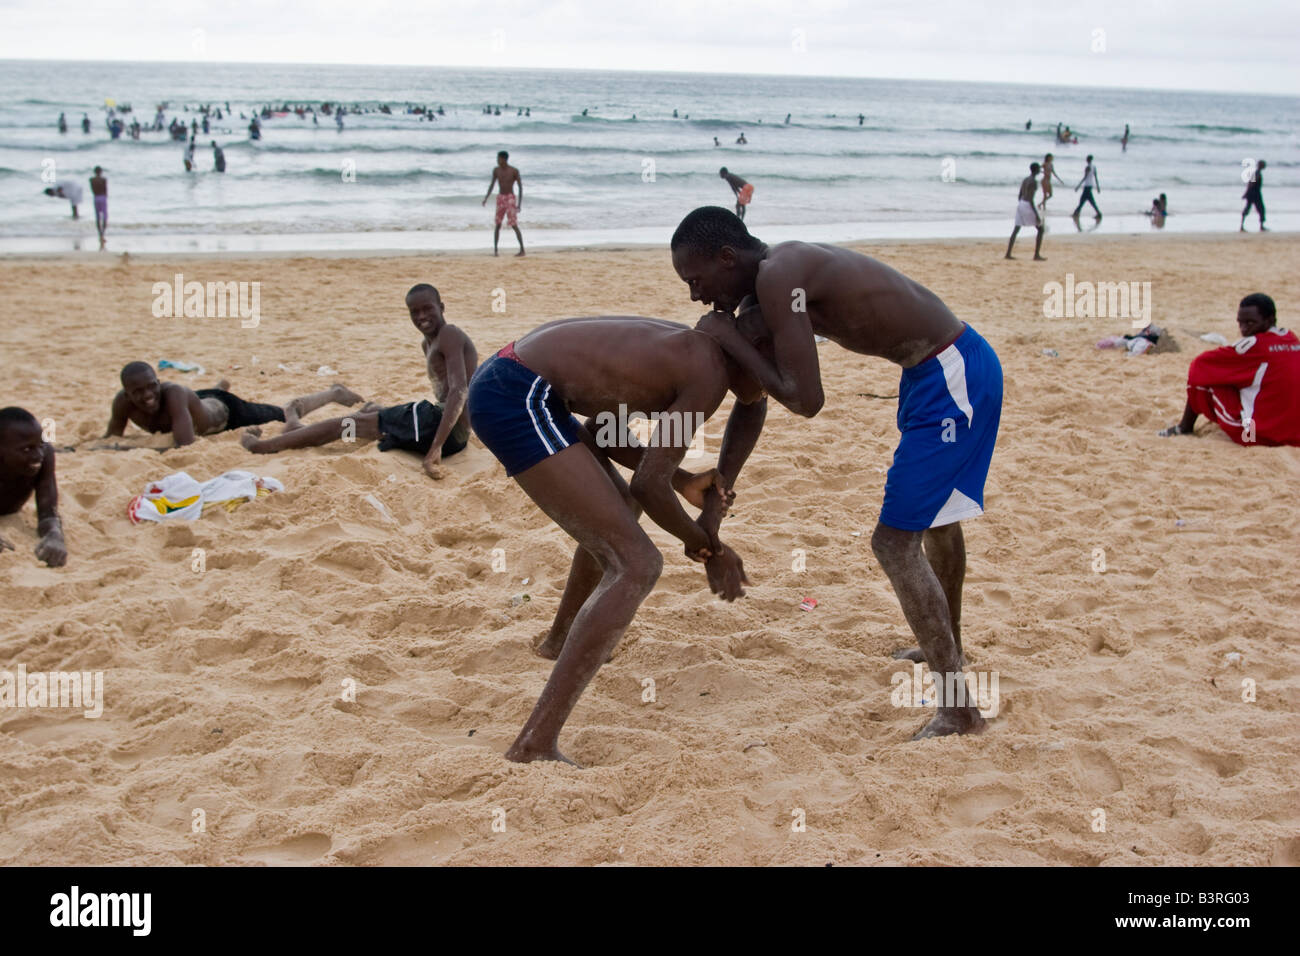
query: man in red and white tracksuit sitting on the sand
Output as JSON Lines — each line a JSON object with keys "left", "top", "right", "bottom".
{"left": 1160, "top": 293, "right": 1300, "bottom": 445}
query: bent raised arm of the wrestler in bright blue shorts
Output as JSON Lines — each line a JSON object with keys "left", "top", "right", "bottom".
{"left": 696, "top": 271, "right": 826, "bottom": 419}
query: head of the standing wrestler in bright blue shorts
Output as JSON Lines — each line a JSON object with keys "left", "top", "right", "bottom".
{"left": 670, "top": 206, "right": 766, "bottom": 312}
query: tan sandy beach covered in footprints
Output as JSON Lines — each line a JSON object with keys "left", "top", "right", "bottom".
{"left": 0, "top": 231, "right": 1300, "bottom": 866}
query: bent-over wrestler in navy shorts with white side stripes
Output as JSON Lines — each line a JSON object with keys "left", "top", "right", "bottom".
{"left": 469, "top": 316, "right": 767, "bottom": 762}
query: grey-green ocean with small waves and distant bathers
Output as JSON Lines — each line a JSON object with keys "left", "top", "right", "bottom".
{"left": 0, "top": 61, "right": 1300, "bottom": 254}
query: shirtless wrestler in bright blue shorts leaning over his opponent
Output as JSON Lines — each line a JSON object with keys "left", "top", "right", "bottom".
{"left": 672, "top": 205, "right": 998, "bottom": 737}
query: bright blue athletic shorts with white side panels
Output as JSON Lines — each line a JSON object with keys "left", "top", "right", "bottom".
{"left": 880, "top": 325, "right": 1002, "bottom": 531}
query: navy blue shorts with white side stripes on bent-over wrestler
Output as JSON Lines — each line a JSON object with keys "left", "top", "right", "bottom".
{"left": 469, "top": 342, "right": 582, "bottom": 476}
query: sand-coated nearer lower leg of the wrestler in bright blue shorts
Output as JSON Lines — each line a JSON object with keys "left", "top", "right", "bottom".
{"left": 871, "top": 523, "right": 984, "bottom": 740}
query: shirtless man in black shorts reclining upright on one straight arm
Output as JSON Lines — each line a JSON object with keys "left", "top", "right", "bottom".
{"left": 241, "top": 284, "right": 478, "bottom": 479}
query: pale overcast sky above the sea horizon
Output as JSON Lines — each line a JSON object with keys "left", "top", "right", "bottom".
{"left": 0, "top": 0, "right": 1300, "bottom": 95}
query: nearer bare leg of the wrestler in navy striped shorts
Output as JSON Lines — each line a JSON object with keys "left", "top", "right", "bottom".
{"left": 506, "top": 445, "right": 663, "bottom": 763}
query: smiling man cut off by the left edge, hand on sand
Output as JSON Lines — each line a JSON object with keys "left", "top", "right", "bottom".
{"left": 0, "top": 406, "right": 68, "bottom": 567}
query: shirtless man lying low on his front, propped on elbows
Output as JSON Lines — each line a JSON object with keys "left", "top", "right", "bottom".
{"left": 104, "top": 362, "right": 361, "bottom": 447}
